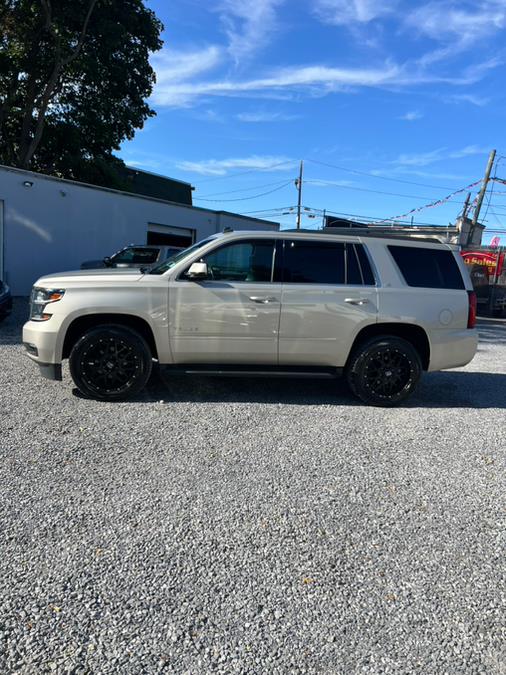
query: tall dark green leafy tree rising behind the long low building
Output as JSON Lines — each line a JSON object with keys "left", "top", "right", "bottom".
{"left": 0, "top": 0, "right": 163, "bottom": 187}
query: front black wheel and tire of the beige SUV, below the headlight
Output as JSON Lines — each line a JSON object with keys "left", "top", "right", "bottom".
{"left": 69, "top": 324, "right": 153, "bottom": 401}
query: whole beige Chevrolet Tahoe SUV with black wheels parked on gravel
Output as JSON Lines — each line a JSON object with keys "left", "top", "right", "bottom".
{"left": 23, "top": 231, "right": 477, "bottom": 405}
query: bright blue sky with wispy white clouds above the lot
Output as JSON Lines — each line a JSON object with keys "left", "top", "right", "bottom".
{"left": 116, "top": 0, "right": 506, "bottom": 243}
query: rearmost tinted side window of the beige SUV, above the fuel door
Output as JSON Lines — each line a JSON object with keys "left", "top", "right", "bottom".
{"left": 388, "top": 246, "right": 465, "bottom": 290}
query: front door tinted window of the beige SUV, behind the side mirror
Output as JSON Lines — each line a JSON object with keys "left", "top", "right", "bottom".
{"left": 202, "top": 239, "right": 274, "bottom": 282}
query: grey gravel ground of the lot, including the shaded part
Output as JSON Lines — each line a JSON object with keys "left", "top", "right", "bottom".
{"left": 0, "top": 301, "right": 506, "bottom": 675}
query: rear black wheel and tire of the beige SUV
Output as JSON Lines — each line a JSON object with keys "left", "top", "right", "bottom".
{"left": 346, "top": 335, "right": 422, "bottom": 407}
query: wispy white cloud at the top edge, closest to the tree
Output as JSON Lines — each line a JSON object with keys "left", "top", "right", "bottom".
{"left": 220, "top": 0, "right": 284, "bottom": 64}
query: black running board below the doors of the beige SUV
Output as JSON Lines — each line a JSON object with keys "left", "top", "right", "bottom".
{"left": 164, "top": 364, "right": 343, "bottom": 379}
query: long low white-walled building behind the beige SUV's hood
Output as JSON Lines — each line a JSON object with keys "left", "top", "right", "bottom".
{"left": 0, "top": 166, "right": 279, "bottom": 295}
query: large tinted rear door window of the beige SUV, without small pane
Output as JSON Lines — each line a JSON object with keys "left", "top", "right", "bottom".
{"left": 283, "top": 240, "right": 345, "bottom": 284}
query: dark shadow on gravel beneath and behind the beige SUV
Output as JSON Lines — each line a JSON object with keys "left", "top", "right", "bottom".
{"left": 133, "top": 367, "right": 506, "bottom": 408}
